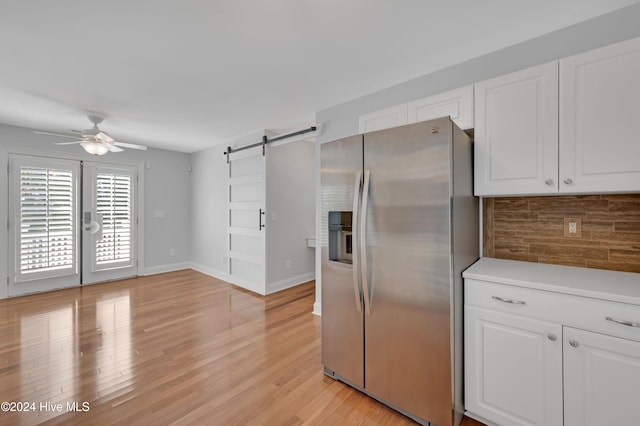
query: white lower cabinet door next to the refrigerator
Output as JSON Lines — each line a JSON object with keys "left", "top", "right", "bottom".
{"left": 464, "top": 306, "right": 562, "bottom": 426}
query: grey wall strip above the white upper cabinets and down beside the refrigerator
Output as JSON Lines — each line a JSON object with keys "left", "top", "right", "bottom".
{"left": 314, "top": 4, "right": 640, "bottom": 314}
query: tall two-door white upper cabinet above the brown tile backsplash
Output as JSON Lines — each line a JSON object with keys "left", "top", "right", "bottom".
{"left": 475, "top": 38, "right": 640, "bottom": 196}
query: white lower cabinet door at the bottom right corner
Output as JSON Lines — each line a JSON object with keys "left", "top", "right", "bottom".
{"left": 564, "top": 327, "right": 640, "bottom": 426}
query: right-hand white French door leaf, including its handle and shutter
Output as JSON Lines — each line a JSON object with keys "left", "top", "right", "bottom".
{"left": 82, "top": 161, "right": 138, "bottom": 284}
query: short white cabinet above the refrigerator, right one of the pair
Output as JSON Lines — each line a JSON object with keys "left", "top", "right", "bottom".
{"left": 408, "top": 86, "right": 473, "bottom": 130}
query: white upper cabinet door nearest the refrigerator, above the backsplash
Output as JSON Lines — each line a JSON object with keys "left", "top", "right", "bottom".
{"left": 474, "top": 62, "right": 558, "bottom": 195}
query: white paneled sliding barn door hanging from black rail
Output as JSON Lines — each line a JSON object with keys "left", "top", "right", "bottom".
{"left": 227, "top": 147, "right": 266, "bottom": 294}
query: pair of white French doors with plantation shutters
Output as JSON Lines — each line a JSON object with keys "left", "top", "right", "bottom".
{"left": 8, "top": 155, "right": 138, "bottom": 296}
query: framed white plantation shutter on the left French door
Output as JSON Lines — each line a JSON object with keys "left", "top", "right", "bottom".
{"left": 12, "top": 156, "right": 78, "bottom": 283}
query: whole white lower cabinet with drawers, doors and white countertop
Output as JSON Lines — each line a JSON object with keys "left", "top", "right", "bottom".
{"left": 463, "top": 259, "right": 640, "bottom": 426}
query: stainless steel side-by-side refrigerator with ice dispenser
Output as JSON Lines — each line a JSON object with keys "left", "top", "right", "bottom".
{"left": 321, "top": 117, "right": 479, "bottom": 426}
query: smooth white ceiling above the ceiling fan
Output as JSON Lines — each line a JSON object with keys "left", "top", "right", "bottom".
{"left": 0, "top": 0, "right": 637, "bottom": 152}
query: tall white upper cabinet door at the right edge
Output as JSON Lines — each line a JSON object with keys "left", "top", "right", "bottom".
{"left": 559, "top": 38, "right": 640, "bottom": 192}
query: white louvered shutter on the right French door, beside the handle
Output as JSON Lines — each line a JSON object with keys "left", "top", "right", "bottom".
{"left": 95, "top": 172, "right": 133, "bottom": 266}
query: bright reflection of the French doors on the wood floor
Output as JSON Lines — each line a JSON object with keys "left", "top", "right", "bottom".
{"left": 20, "top": 294, "right": 133, "bottom": 403}
